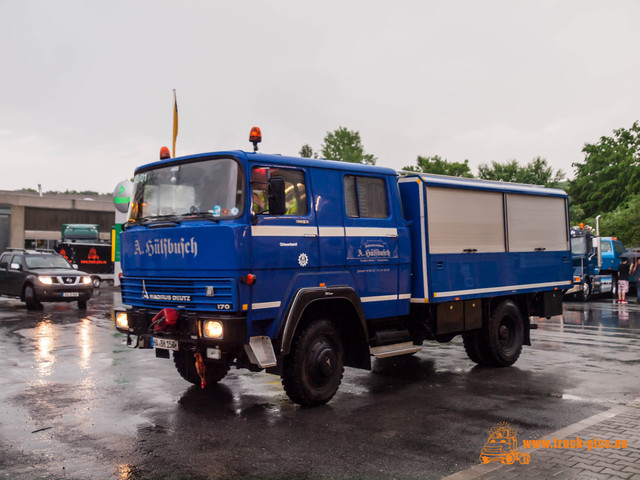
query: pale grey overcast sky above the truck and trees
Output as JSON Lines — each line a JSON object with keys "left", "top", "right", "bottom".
{"left": 0, "top": 0, "right": 640, "bottom": 193}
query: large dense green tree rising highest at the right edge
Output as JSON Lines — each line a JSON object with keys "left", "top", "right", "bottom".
{"left": 569, "top": 121, "right": 640, "bottom": 217}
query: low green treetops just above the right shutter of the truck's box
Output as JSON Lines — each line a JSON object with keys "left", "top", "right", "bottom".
{"left": 478, "top": 157, "right": 565, "bottom": 188}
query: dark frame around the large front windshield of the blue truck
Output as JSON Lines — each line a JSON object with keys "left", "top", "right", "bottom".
{"left": 126, "top": 154, "right": 247, "bottom": 225}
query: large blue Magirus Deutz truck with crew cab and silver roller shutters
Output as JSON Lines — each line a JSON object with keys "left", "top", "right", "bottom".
{"left": 114, "top": 133, "right": 572, "bottom": 406}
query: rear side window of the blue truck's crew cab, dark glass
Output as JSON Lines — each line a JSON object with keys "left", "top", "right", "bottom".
{"left": 344, "top": 175, "right": 389, "bottom": 218}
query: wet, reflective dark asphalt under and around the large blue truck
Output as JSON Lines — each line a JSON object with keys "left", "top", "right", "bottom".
{"left": 0, "top": 286, "right": 640, "bottom": 480}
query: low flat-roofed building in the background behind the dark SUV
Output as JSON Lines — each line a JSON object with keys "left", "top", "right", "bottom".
{"left": 0, "top": 190, "right": 115, "bottom": 252}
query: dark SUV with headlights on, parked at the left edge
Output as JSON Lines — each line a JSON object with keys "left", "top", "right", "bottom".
{"left": 0, "top": 249, "right": 93, "bottom": 310}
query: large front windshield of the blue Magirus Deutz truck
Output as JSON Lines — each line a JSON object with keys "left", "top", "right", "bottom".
{"left": 129, "top": 158, "right": 244, "bottom": 221}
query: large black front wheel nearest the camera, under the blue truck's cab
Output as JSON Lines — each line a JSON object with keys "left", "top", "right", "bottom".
{"left": 282, "top": 319, "right": 344, "bottom": 407}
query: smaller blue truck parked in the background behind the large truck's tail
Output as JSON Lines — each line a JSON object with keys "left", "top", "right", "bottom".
{"left": 566, "top": 223, "right": 626, "bottom": 301}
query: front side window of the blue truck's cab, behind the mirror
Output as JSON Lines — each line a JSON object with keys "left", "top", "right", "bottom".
{"left": 251, "top": 167, "right": 309, "bottom": 216}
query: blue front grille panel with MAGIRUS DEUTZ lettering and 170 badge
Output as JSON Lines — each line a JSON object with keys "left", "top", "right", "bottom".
{"left": 122, "top": 277, "right": 238, "bottom": 312}
